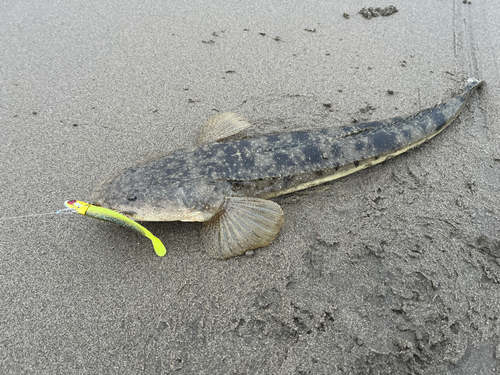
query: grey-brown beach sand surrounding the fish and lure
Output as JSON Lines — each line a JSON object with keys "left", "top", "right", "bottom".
{"left": 0, "top": 0, "right": 500, "bottom": 374}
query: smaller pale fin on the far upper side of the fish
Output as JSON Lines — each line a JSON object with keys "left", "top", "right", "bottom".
{"left": 196, "top": 112, "right": 252, "bottom": 146}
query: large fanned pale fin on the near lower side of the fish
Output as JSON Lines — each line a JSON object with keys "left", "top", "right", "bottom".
{"left": 201, "top": 197, "right": 284, "bottom": 259}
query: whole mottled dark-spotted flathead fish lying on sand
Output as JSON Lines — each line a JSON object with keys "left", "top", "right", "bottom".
{"left": 92, "top": 79, "right": 483, "bottom": 259}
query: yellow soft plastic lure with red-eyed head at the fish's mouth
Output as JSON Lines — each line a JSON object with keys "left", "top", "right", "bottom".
{"left": 64, "top": 200, "right": 167, "bottom": 257}
